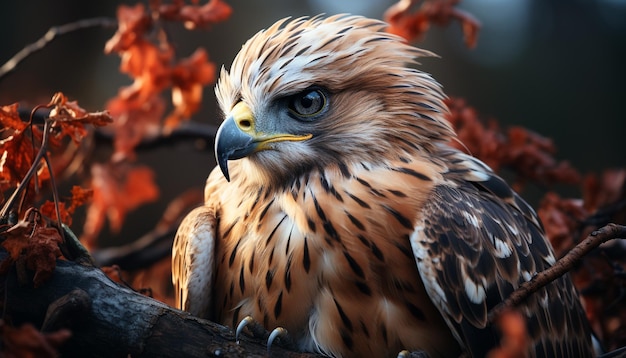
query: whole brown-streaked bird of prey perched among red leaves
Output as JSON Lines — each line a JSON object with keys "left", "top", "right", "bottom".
{"left": 172, "top": 15, "right": 592, "bottom": 357}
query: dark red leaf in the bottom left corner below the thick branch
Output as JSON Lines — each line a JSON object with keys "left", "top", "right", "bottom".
{"left": 0, "top": 321, "right": 72, "bottom": 358}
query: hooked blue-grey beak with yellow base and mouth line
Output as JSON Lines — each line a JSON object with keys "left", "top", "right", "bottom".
{"left": 215, "top": 102, "right": 313, "bottom": 181}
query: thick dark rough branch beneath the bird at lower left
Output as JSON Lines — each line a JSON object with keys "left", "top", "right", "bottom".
{"left": 0, "top": 253, "right": 315, "bottom": 357}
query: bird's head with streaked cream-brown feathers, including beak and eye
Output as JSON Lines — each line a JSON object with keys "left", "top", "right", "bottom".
{"left": 215, "top": 15, "right": 454, "bottom": 186}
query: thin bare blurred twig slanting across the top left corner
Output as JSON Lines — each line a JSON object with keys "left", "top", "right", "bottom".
{"left": 0, "top": 17, "right": 117, "bottom": 79}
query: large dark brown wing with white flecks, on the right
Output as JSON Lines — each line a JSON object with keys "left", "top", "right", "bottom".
{"left": 411, "top": 154, "right": 591, "bottom": 357}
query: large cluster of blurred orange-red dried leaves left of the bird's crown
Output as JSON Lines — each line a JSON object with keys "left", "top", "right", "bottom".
{"left": 105, "top": 0, "right": 227, "bottom": 160}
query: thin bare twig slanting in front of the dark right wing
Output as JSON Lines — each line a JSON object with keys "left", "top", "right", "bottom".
{"left": 488, "top": 224, "right": 626, "bottom": 323}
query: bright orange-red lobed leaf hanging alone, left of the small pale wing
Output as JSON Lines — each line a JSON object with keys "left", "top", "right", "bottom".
{"left": 82, "top": 163, "right": 159, "bottom": 248}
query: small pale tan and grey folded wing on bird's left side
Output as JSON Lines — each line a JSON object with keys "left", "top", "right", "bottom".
{"left": 172, "top": 206, "right": 217, "bottom": 318}
